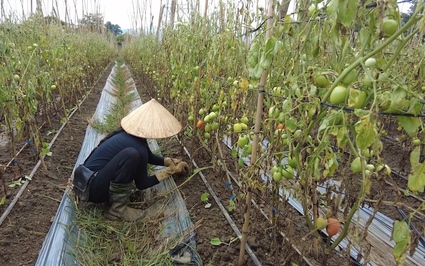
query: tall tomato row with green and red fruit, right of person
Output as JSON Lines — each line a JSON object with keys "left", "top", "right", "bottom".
{"left": 123, "top": 0, "right": 425, "bottom": 263}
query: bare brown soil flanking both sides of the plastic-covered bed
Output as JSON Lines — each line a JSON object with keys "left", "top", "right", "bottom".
{"left": 0, "top": 60, "right": 417, "bottom": 265}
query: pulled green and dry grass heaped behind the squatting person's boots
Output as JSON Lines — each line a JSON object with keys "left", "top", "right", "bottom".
{"left": 73, "top": 203, "right": 177, "bottom": 265}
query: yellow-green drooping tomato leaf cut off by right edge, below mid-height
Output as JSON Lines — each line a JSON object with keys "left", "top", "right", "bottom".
{"left": 407, "top": 147, "right": 425, "bottom": 192}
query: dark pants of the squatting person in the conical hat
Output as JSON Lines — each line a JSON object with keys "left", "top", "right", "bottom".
{"left": 89, "top": 148, "right": 159, "bottom": 203}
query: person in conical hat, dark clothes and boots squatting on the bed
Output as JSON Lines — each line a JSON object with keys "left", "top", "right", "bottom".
{"left": 74, "top": 99, "right": 189, "bottom": 221}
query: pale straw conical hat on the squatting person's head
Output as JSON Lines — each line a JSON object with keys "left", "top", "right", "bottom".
{"left": 121, "top": 99, "right": 182, "bottom": 139}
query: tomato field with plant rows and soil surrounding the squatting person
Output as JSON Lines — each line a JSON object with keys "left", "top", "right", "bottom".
{"left": 0, "top": 0, "right": 425, "bottom": 266}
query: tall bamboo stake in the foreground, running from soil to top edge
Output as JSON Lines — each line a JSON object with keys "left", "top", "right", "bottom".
{"left": 238, "top": 0, "right": 274, "bottom": 266}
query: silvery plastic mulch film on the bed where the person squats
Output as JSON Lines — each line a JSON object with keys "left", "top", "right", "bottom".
{"left": 35, "top": 65, "right": 202, "bottom": 266}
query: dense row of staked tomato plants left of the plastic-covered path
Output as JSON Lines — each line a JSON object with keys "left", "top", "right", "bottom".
{"left": 0, "top": 16, "right": 115, "bottom": 160}
